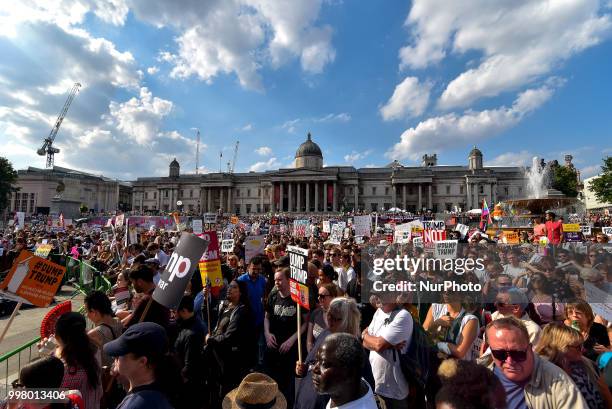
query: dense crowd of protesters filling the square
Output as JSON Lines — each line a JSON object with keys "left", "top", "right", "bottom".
{"left": 0, "top": 210, "right": 612, "bottom": 409}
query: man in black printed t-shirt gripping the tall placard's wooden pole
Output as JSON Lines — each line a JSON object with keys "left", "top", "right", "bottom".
{"left": 264, "top": 268, "right": 308, "bottom": 408}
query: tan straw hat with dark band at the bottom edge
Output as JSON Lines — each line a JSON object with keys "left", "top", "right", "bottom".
{"left": 222, "top": 372, "right": 287, "bottom": 409}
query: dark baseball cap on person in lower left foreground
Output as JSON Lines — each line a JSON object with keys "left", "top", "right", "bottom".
{"left": 104, "top": 322, "right": 168, "bottom": 356}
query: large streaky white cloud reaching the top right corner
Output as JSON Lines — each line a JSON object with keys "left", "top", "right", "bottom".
{"left": 399, "top": 0, "right": 612, "bottom": 109}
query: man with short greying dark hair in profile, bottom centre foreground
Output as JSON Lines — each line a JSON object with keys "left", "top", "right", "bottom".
{"left": 312, "top": 333, "right": 378, "bottom": 409}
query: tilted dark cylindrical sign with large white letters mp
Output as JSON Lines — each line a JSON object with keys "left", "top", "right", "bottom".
{"left": 153, "top": 233, "right": 208, "bottom": 309}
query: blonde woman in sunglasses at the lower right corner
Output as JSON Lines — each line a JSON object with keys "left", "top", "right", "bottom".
{"left": 535, "top": 323, "right": 612, "bottom": 409}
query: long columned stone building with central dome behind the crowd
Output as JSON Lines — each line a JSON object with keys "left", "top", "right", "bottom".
{"left": 132, "top": 134, "right": 526, "bottom": 215}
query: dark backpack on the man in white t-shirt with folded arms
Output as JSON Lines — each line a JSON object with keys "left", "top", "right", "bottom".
{"left": 389, "top": 309, "right": 442, "bottom": 402}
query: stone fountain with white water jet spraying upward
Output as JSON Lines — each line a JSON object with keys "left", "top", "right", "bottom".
{"left": 504, "top": 156, "right": 577, "bottom": 216}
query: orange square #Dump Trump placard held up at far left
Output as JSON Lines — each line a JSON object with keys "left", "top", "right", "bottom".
{"left": 0, "top": 251, "right": 66, "bottom": 307}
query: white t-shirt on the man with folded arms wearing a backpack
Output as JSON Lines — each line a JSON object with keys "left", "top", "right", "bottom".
{"left": 368, "top": 308, "right": 414, "bottom": 399}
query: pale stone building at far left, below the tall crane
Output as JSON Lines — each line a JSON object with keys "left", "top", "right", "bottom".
{"left": 9, "top": 166, "right": 132, "bottom": 217}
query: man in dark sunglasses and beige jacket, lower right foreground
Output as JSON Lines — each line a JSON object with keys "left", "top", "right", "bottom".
{"left": 486, "top": 317, "right": 588, "bottom": 409}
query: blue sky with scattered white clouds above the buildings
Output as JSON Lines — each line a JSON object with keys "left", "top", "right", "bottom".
{"left": 0, "top": 0, "right": 612, "bottom": 179}
